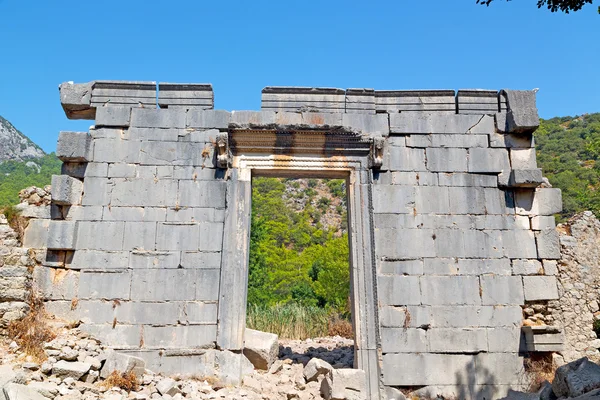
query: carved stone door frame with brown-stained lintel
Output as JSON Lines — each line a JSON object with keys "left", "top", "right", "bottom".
{"left": 217, "top": 130, "right": 380, "bottom": 398}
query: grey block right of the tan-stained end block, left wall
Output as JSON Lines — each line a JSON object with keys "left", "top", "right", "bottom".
{"left": 77, "top": 271, "right": 131, "bottom": 300}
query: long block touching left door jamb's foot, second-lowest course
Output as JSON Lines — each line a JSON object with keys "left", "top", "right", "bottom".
{"left": 144, "top": 325, "right": 217, "bottom": 348}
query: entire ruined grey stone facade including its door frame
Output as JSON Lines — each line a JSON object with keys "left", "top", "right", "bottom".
{"left": 37, "top": 81, "right": 561, "bottom": 398}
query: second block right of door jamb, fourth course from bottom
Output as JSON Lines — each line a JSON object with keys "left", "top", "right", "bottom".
{"left": 420, "top": 276, "right": 481, "bottom": 306}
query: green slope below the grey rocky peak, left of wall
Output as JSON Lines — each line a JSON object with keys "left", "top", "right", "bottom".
{"left": 0, "top": 153, "right": 61, "bottom": 207}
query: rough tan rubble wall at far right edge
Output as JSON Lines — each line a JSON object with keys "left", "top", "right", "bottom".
{"left": 549, "top": 211, "right": 600, "bottom": 362}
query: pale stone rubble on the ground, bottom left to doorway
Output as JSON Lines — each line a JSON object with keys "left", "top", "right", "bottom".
{"left": 0, "top": 327, "right": 362, "bottom": 400}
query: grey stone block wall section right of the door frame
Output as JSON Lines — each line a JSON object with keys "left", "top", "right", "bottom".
{"left": 366, "top": 92, "right": 561, "bottom": 397}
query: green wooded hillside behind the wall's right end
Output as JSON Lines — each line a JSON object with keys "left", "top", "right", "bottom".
{"left": 535, "top": 113, "right": 600, "bottom": 220}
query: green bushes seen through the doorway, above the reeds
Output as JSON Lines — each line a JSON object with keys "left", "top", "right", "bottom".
{"left": 248, "top": 178, "right": 350, "bottom": 314}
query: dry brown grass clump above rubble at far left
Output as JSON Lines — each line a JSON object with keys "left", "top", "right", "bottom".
{"left": 8, "top": 290, "right": 56, "bottom": 362}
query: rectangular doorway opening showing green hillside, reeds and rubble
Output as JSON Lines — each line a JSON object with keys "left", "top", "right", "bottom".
{"left": 246, "top": 176, "right": 355, "bottom": 368}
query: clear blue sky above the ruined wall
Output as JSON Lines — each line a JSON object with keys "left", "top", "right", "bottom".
{"left": 0, "top": 0, "right": 600, "bottom": 151}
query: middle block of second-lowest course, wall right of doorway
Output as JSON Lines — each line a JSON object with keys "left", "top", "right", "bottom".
{"left": 427, "top": 328, "right": 488, "bottom": 354}
